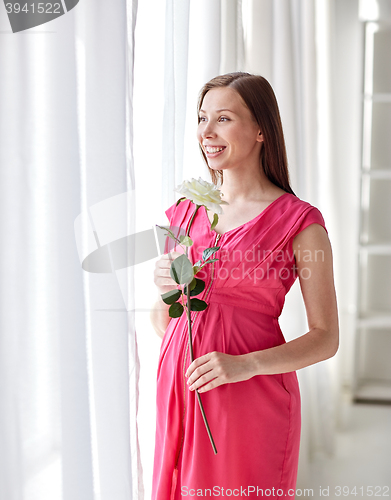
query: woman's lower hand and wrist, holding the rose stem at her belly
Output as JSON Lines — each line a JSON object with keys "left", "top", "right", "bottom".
{"left": 185, "top": 351, "right": 253, "bottom": 392}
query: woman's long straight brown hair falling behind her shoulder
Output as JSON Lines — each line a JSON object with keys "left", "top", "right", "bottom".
{"left": 197, "top": 72, "right": 295, "bottom": 195}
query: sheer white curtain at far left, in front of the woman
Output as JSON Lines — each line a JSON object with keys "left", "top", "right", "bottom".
{"left": 0, "top": 0, "right": 142, "bottom": 500}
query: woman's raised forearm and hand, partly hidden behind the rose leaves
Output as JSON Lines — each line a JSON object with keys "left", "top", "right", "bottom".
{"left": 149, "top": 252, "right": 183, "bottom": 338}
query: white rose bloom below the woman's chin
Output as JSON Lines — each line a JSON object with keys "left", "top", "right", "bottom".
{"left": 175, "top": 177, "right": 229, "bottom": 214}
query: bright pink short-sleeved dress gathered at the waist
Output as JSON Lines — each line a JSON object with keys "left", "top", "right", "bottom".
{"left": 152, "top": 193, "right": 326, "bottom": 500}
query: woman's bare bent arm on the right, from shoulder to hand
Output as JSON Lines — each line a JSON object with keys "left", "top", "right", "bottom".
{"left": 187, "top": 224, "right": 339, "bottom": 392}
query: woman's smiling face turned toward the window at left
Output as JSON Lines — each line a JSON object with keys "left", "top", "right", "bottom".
{"left": 197, "top": 87, "right": 263, "bottom": 176}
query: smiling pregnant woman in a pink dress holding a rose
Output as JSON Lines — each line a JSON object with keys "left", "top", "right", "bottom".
{"left": 151, "top": 73, "right": 339, "bottom": 500}
